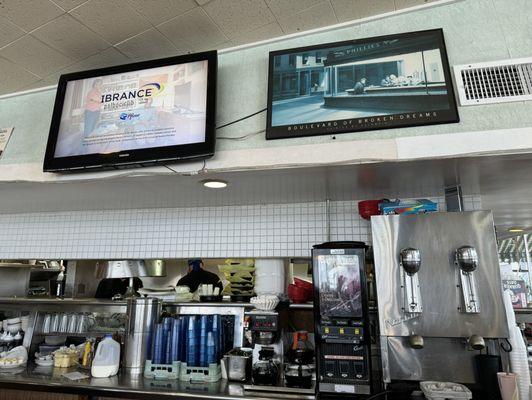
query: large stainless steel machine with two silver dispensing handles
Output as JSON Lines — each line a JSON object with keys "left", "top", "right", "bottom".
{"left": 371, "top": 211, "right": 508, "bottom": 383}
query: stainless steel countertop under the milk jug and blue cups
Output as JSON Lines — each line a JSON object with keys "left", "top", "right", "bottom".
{"left": 0, "top": 364, "right": 315, "bottom": 400}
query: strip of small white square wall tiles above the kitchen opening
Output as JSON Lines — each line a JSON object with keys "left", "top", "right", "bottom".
{"left": 0, "top": 196, "right": 481, "bottom": 260}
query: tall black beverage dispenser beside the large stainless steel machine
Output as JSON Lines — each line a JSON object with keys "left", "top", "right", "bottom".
{"left": 312, "top": 242, "right": 371, "bottom": 398}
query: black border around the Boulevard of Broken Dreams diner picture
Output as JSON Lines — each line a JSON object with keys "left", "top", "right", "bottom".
{"left": 266, "top": 28, "right": 460, "bottom": 140}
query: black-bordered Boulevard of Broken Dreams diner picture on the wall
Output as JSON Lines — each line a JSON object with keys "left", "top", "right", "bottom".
{"left": 266, "top": 29, "right": 459, "bottom": 139}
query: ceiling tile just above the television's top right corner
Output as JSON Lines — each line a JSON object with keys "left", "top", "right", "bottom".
{"left": 157, "top": 7, "right": 227, "bottom": 49}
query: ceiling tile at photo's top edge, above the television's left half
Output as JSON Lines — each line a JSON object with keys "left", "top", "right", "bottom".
{"left": 71, "top": 0, "right": 151, "bottom": 44}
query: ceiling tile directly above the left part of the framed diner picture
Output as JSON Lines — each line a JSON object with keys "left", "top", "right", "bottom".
{"left": 277, "top": 2, "right": 338, "bottom": 33}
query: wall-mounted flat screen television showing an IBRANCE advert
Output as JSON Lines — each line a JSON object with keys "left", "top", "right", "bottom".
{"left": 43, "top": 51, "right": 217, "bottom": 171}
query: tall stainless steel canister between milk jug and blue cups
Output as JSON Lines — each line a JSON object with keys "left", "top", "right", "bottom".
{"left": 124, "top": 297, "right": 159, "bottom": 374}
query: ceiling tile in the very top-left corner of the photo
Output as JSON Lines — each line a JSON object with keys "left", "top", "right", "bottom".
{"left": 0, "top": 0, "right": 64, "bottom": 31}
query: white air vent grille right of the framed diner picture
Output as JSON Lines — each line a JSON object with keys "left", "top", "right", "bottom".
{"left": 454, "top": 58, "right": 532, "bottom": 106}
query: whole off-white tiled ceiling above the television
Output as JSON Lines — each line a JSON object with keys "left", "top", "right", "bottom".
{"left": 0, "top": 0, "right": 435, "bottom": 95}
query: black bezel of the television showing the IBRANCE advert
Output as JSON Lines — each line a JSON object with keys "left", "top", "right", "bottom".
{"left": 43, "top": 50, "right": 218, "bottom": 172}
